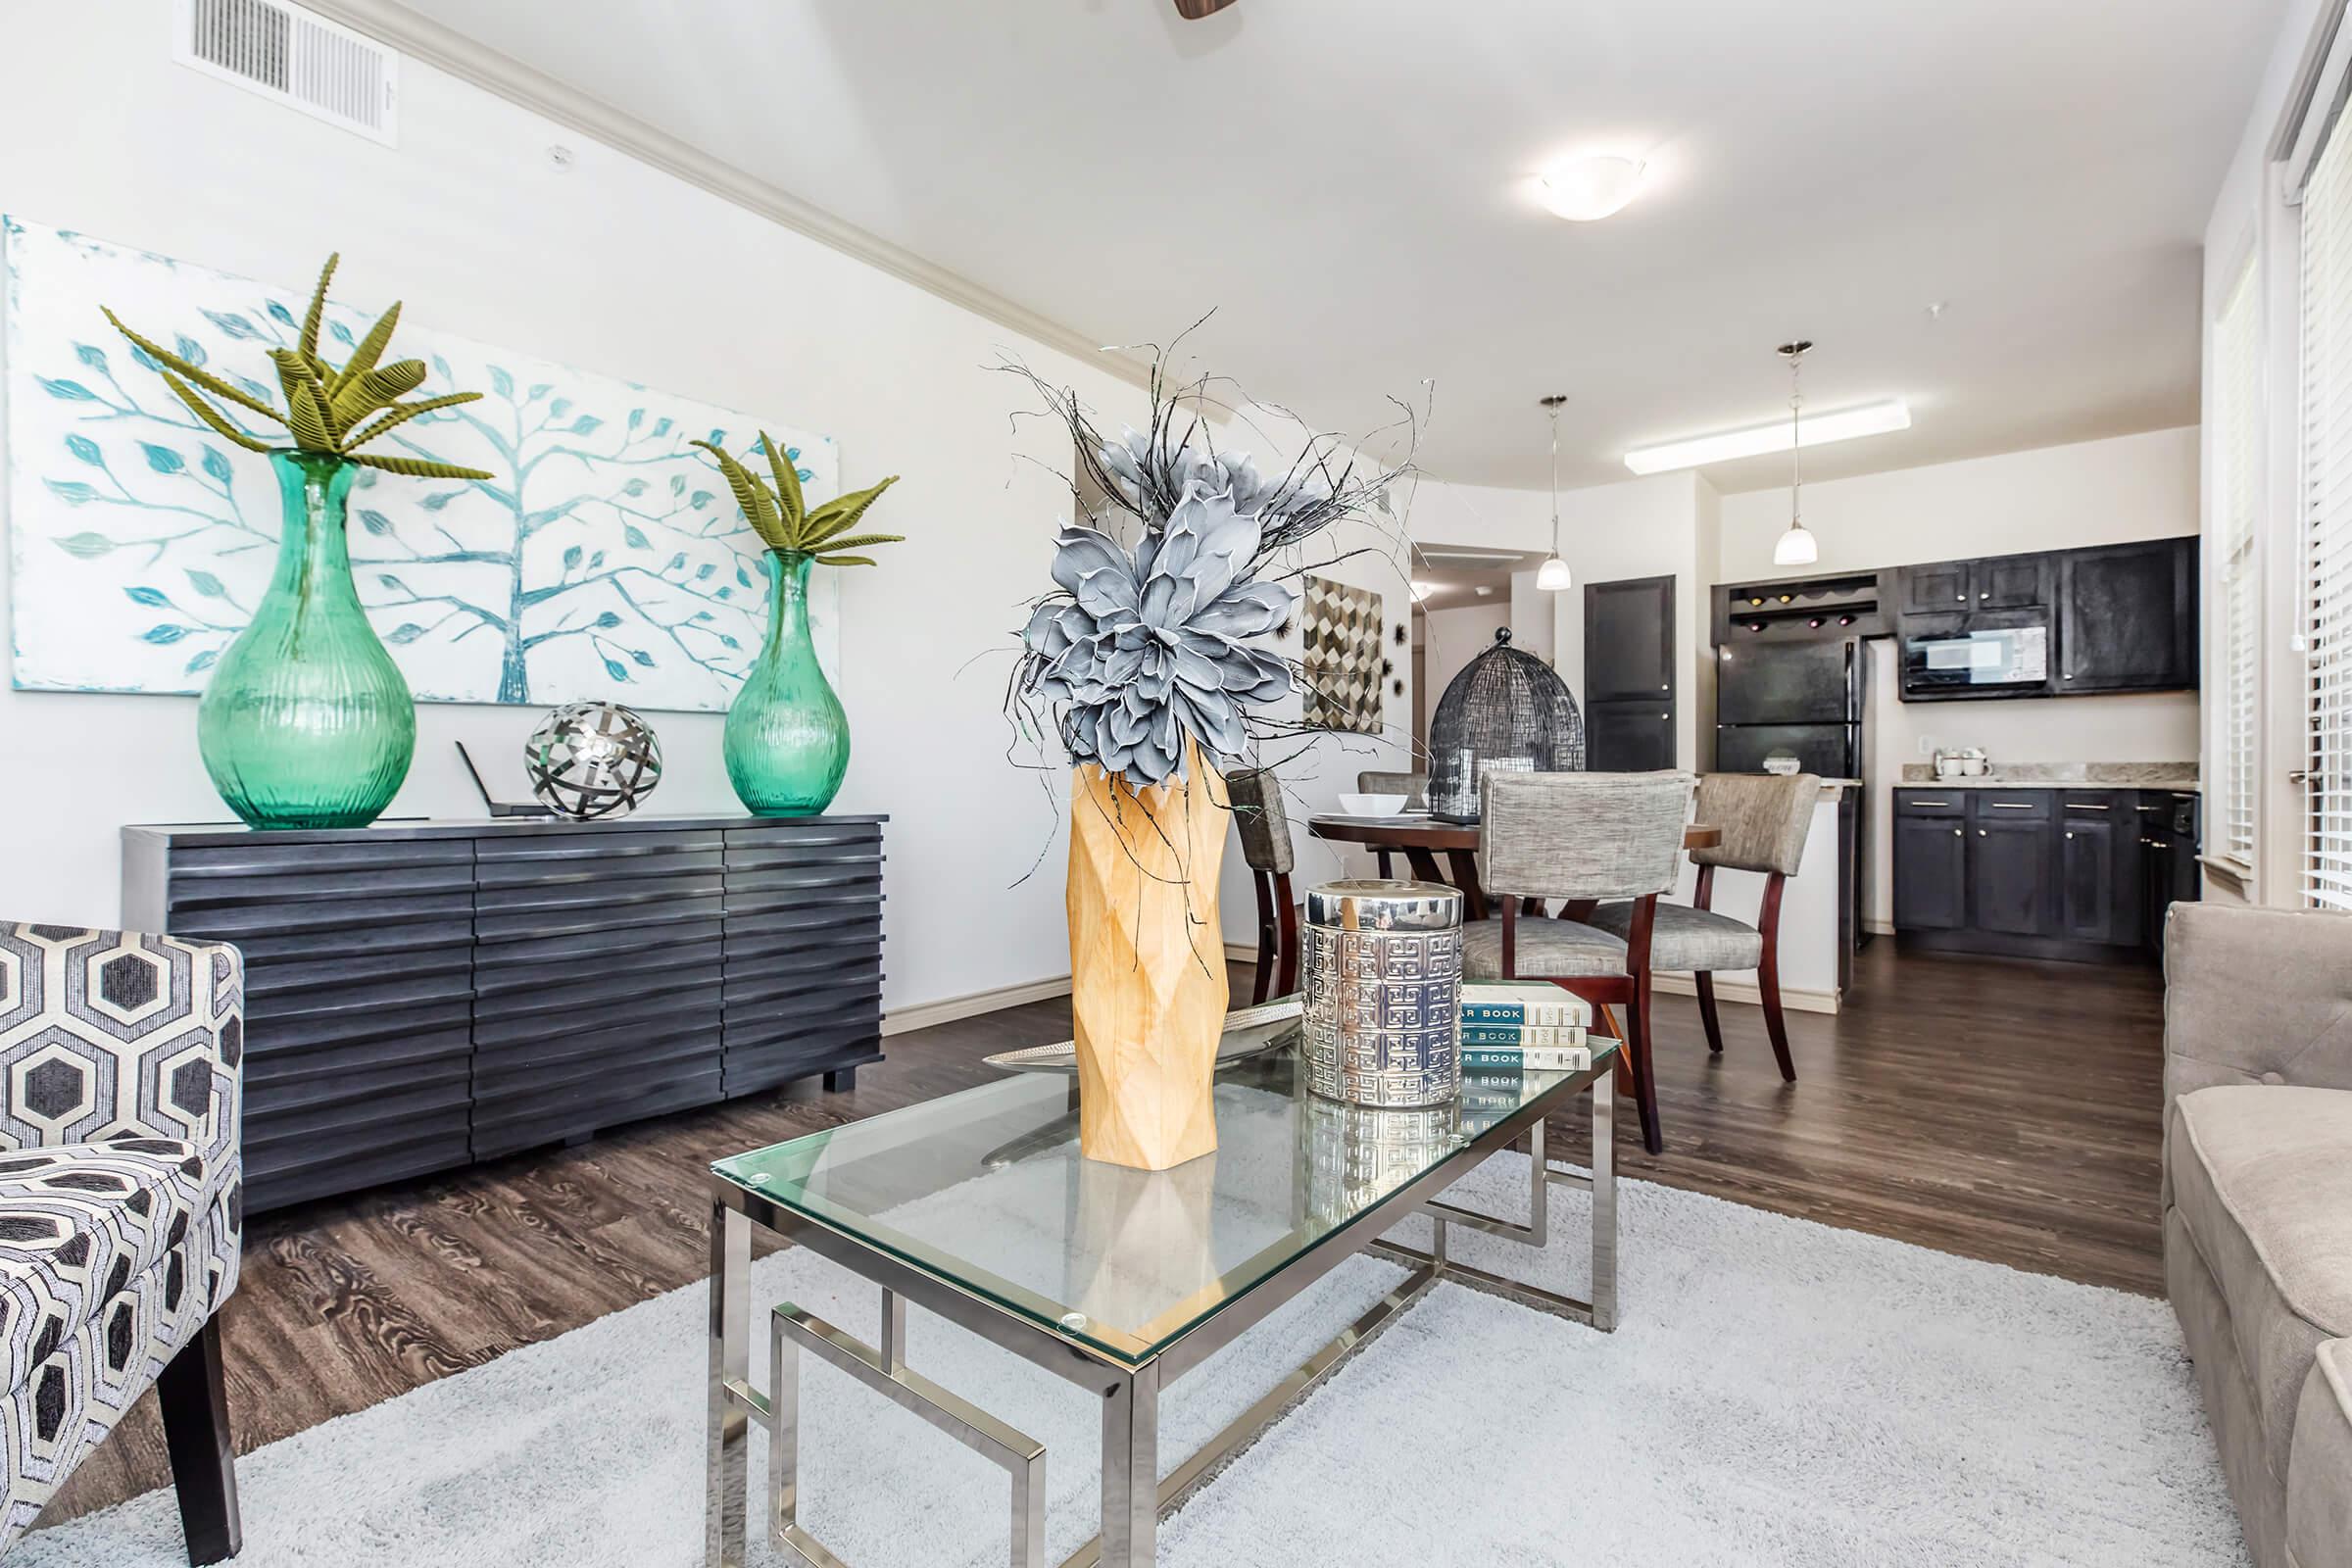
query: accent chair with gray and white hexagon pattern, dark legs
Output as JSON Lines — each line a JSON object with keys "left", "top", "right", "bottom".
{"left": 0, "top": 926, "right": 245, "bottom": 1563}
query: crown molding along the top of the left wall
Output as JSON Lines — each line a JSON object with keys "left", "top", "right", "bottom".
{"left": 299, "top": 0, "right": 1151, "bottom": 385}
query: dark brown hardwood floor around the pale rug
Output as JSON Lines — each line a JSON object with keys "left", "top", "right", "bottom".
{"left": 49, "top": 938, "right": 2164, "bottom": 1519}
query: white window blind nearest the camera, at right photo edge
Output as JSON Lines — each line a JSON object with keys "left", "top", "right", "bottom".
{"left": 2300, "top": 110, "right": 2352, "bottom": 909}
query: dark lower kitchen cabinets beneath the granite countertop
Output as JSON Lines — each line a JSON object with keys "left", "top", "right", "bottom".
{"left": 1893, "top": 785, "right": 2197, "bottom": 964}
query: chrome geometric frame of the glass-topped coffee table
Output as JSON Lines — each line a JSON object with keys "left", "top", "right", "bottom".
{"left": 704, "top": 1055, "right": 1616, "bottom": 1568}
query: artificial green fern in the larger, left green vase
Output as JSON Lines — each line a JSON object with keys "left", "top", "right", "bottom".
{"left": 99, "top": 254, "right": 496, "bottom": 479}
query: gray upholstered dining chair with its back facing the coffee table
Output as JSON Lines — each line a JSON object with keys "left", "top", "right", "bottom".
{"left": 1463, "top": 771, "right": 1693, "bottom": 1154}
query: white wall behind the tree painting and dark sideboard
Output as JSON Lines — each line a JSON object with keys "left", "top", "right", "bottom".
{"left": 0, "top": 0, "right": 1409, "bottom": 1008}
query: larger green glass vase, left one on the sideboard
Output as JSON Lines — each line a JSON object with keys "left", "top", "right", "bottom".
{"left": 195, "top": 452, "right": 416, "bottom": 827}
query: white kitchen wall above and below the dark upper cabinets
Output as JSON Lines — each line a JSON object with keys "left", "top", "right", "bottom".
{"left": 1712, "top": 428, "right": 2199, "bottom": 921}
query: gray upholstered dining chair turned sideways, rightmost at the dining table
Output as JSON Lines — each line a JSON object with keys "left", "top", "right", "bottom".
{"left": 1592, "top": 773, "right": 1821, "bottom": 1084}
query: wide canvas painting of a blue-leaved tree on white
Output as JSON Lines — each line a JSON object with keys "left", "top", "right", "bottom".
{"left": 0, "top": 219, "right": 840, "bottom": 712}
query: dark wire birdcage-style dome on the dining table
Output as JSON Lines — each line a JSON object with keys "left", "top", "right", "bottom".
{"left": 1430, "top": 625, "right": 1586, "bottom": 823}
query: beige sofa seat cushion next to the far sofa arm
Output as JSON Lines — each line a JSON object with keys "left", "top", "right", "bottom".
{"left": 2166, "top": 1084, "right": 2352, "bottom": 1481}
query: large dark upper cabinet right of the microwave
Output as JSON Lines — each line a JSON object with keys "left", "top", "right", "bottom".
{"left": 2053, "top": 538, "right": 2197, "bottom": 696}
